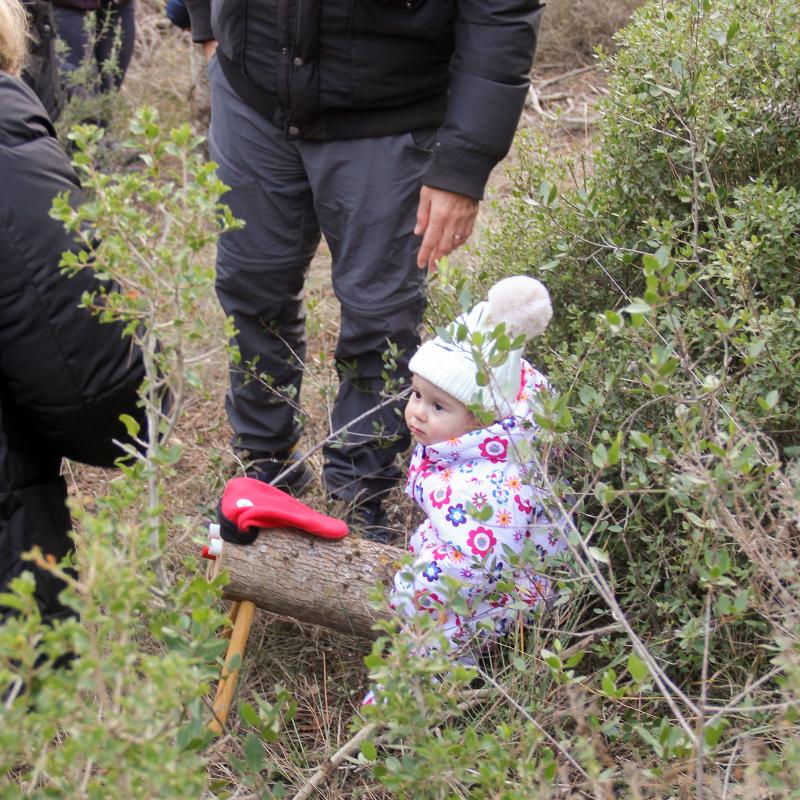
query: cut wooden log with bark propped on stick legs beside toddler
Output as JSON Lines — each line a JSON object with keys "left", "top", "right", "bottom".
{"left": 214, "top": 528, "right": 404, "bottom": 639}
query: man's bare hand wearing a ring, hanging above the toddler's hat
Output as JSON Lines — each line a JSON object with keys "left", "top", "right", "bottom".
{"left": 414, "top": 186, "right": 478, "bottom": 270}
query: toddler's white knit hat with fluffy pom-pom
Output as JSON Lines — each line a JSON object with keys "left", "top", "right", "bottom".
{"left": 409, "top": 275, "right": 553, "bottom": 419}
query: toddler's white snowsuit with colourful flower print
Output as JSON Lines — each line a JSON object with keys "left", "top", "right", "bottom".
{"left": 391, "top": 360, "right": 566, "bottom": 663}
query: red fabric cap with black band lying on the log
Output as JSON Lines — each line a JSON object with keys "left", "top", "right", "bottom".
{"left": 221, "top": 478, "right": 347, "bottom": 539}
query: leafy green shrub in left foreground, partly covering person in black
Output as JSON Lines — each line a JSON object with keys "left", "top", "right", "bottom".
{"left": 0, "top": 109, "right": 234, "bottom": 800}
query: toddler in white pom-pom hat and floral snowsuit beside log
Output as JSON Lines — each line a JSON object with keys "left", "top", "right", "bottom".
{"left": 391, "top": 276, "right": 567, "bottom": 664}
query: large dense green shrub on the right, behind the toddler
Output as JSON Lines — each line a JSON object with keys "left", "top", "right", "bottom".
{"left": 374, "top": 0, "right": 800, "bottom": 797}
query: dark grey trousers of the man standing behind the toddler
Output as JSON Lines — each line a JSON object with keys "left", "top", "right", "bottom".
{"left": 209, "top": 59, "right": 435, "bottom": 499}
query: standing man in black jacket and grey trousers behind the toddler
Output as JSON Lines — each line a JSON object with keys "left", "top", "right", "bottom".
{"left": 187, "top": 0, "right": 542, "bottom": 538}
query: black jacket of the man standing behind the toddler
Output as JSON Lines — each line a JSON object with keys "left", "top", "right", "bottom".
{"left": 186, "top": 0, "right": 542, "bottom": 198}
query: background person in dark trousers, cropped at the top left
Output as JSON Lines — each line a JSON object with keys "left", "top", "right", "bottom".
{"left": 52, "top": 0, "right": 136, "bottom": 93}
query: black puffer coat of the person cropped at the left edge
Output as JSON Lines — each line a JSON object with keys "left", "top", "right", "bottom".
{"left": 0, "top": 72, "right": 144, "bottom": 618}
